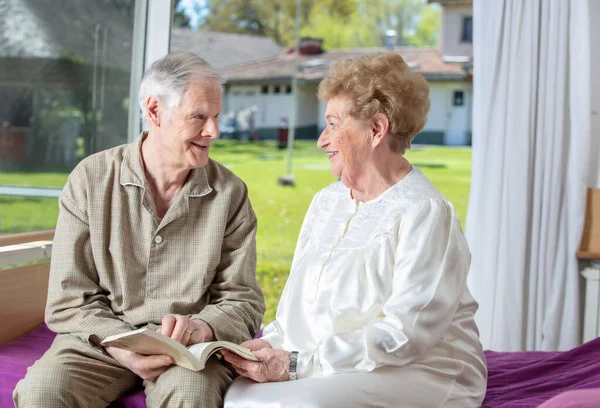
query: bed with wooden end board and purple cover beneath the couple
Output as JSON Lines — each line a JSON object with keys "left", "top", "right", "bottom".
{"left": 0, "top": 235, "right": 600, "bottom": 408}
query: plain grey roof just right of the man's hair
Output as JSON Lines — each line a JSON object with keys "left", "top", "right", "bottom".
{"left": 171, "top": 28, "right": 283, "bottom": 70}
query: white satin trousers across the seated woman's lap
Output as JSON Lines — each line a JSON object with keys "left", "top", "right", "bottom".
{"left": 225, "top": 364, "right": 486, "bottom": 408}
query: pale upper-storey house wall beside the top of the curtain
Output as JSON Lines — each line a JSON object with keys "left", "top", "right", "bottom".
{"left": 440, "top": 4, "right": 473, "bottom": 57}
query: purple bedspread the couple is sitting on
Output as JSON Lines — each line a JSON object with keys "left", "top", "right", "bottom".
{"left": 0, "top": 325, "right": 600, "bottom": 408}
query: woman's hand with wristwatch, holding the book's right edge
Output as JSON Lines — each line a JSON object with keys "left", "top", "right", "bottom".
{"left": 221, "top": 339, "right": 290, "bottom": 383}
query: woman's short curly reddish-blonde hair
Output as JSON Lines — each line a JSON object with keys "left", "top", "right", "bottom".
{"left": 318, "top": 53, "right": 430, "bottom": 153}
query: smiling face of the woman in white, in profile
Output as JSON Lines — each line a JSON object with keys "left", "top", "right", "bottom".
{"left": 317, "top": 96, "right": 372, "bottom": 187}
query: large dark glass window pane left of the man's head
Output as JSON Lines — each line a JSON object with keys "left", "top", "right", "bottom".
{"left": 0, "top": 0, "right": 146, "bottom": 235}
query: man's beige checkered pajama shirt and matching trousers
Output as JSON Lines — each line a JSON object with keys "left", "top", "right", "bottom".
{"left": 15, "top": 135, "right": 265, "bottom": 406}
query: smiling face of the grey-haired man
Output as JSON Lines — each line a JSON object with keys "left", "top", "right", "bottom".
{"left": 161, "top": 79, "right": 222, "bottom": 169}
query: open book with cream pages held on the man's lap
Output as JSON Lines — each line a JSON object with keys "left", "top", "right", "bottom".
{"left": 101, "top": 328, "right": 258, "bottom": 371}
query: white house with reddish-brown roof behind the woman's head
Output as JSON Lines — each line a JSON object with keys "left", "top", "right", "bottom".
{"left": 222, "top": 1, "right": 473, "bottom": 146}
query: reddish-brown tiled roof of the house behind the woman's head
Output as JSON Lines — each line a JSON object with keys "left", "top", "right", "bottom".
{"left": 222, "top": 47, "right": 466, "bottom": 82}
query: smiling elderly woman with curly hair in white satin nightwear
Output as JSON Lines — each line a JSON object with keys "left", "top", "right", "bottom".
{"left": 224, "top": 54, "right": 487, "bottom": 408}
